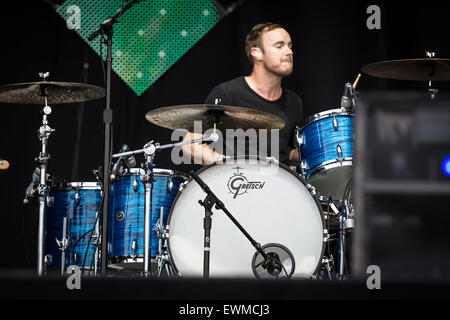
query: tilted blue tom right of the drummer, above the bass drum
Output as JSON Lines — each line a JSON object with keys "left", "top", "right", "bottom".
{"left": 295, "top": 109, "right": 354, "bottom": 200}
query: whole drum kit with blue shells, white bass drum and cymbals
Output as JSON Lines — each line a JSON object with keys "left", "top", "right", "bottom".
{"left": 0, "top": 52, "right": 450, "bottom": 279}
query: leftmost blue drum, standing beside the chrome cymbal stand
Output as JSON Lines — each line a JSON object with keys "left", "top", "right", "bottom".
{"left": 44, "top": 182, "right": 101, "bottom": 269}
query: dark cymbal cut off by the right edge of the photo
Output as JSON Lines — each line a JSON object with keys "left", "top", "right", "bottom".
{"left": 361, "top": 58, "right": 450, "bottom": 81}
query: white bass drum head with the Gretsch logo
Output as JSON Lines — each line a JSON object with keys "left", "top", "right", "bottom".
{"left": 166, "top": 158, "right": 326, "bottom": 278}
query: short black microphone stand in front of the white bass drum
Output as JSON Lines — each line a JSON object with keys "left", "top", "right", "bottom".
{"left": 190, "top": 171, "right": 282, "bottom": 279}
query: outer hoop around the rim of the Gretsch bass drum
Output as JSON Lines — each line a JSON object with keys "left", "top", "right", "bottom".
{"left": 166, "top": 156, "right": 328, "bottom": 277}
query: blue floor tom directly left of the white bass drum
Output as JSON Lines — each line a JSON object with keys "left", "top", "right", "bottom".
{"left": 108, "top": 169, "right": 186, "bottom": 269}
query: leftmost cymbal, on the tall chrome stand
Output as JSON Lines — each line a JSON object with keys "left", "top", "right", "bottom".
{"left": 0, "top": 81, "right": 105, "bottom": 105}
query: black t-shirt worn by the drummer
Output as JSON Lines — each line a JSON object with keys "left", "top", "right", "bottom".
{"left": 205, "top": 76, "right": 303, "bottom": 163}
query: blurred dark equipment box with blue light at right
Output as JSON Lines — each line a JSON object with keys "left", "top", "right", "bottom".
{"left": 351, "top": 90, "right": 450, "bottom": 281}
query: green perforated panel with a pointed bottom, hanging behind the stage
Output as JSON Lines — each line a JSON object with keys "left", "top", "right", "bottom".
{"left": 57, "top": 0, "right": 223, "bottom": 96}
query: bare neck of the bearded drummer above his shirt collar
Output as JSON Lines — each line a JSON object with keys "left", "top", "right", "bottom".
{"left": 245, "top": 69, "right": 283, "bottom": 101}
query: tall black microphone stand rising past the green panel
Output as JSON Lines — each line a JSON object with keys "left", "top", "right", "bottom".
{"left": 88, "top": 0, "right": 140, "bottom": 276}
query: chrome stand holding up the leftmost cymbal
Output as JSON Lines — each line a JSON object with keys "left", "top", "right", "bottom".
{"left": 35, "top": 77, "right": 55, "bottom": 276}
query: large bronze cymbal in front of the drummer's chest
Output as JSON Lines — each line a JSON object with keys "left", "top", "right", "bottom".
{"left": 145, "top": 104, "right": 285, "bottom": 132}
